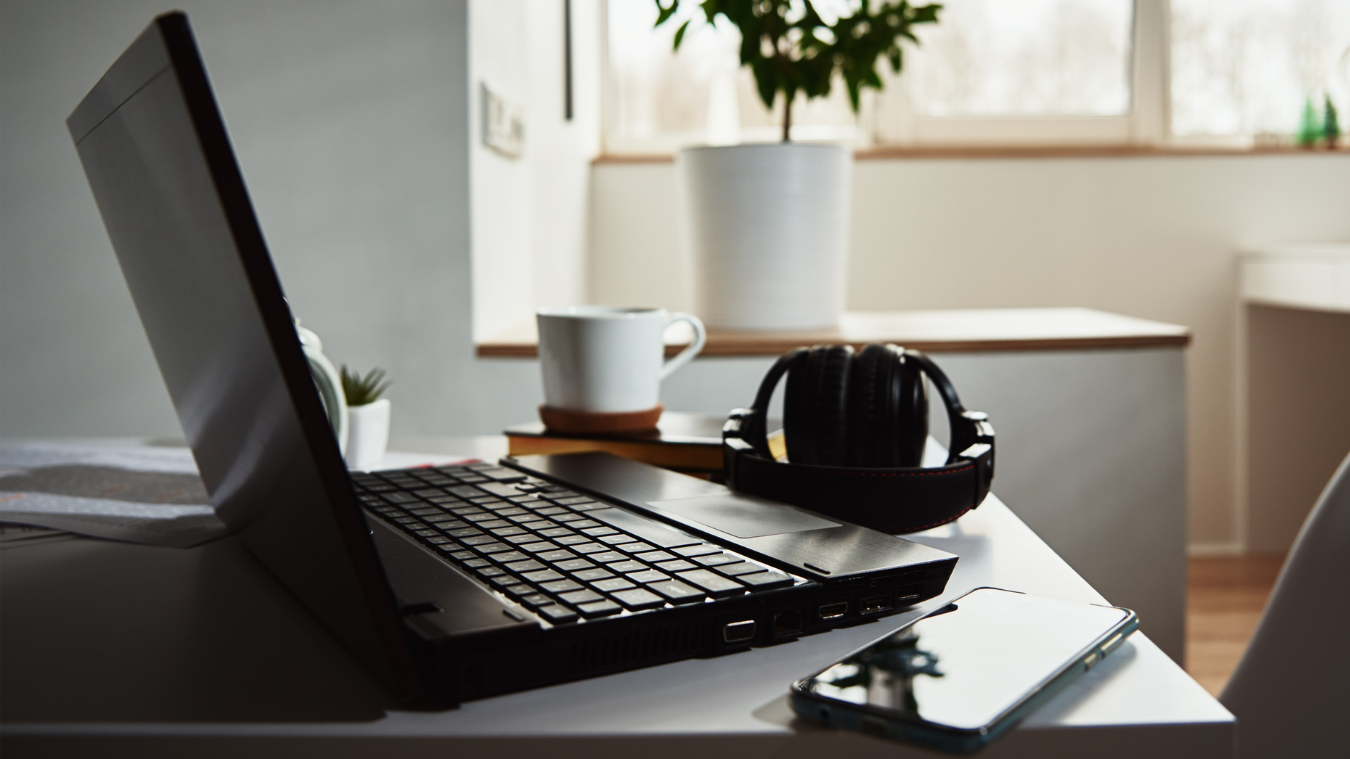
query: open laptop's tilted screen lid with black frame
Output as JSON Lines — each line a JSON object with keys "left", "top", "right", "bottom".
{"left": 66, "top": 14, "right": 419, "bottom": 694}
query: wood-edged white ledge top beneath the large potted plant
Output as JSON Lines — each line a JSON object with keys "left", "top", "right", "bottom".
{"left": 478, "top": 308, "right": 1191, "bottom": 358}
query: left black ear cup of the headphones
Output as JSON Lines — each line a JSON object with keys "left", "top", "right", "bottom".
{"left": 783, "top": 346, "right": 853, "bottom": 466}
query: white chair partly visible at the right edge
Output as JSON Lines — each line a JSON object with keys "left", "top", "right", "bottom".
{"left": 1219, "top": 455, "right": 1350, "bottom": 759}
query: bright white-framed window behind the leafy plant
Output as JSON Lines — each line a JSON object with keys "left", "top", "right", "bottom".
{"left": 605, "top": 0, "right": 1350, "bottom": 153}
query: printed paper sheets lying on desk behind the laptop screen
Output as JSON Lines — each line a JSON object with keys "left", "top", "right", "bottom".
{"left": 0, "top": 443, "right": 477, "bottom": 548}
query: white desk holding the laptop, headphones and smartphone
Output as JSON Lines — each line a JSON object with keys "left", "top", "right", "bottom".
{"left": 0, "top": 444, "right": 1235, "bottom": 759}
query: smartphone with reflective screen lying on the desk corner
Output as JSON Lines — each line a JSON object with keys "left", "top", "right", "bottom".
{"left": 791, "top": 587, "right": 1139, "bottom": 754}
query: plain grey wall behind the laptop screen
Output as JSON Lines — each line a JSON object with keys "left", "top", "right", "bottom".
{"left": 0, "top": 0, "right": 540, "bottom": 436}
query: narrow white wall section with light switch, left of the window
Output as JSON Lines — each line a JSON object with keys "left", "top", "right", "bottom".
{"left": 468, "top": 0, "right": 601, "bottom": 339}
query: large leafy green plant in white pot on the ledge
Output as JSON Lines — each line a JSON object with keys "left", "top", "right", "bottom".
{"left": 656, "top": 0, "right": 941, "bottom": 330}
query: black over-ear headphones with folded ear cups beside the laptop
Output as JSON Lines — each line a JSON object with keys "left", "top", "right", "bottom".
{"left": 722, "top": 344, "right": 994, "bottom": 535}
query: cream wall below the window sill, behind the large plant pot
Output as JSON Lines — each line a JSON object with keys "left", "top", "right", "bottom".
{"left": 591, "top": 154, "right": 1350, "bottom": 548}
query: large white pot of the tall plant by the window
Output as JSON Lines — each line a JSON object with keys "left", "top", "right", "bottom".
{"left": 676, "top": 143, "right": 853, "bottom": 330}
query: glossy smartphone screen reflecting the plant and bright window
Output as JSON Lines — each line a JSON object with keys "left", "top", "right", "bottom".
{"left": 803, "top": 589, "right": 1130, "bottom": 729}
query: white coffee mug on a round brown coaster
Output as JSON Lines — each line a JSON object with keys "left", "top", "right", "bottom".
{"left": 537, "top": 305, "right": 707, "bottom": 413}
